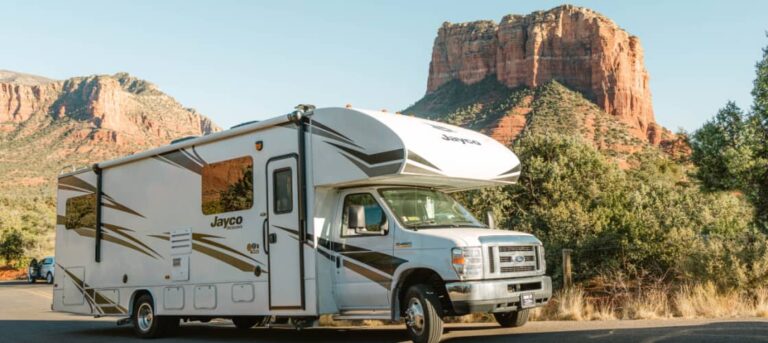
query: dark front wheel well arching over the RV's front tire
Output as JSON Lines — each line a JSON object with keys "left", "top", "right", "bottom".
{"left": 392, "top": 268, "right": 453, "bottom": 316}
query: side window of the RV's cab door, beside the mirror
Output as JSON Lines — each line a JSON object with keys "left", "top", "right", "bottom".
{"left": 341, "top": 193, "right": 389, "bottom": 237}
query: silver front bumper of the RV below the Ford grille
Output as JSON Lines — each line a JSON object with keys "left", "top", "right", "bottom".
{"left": 445, "top": 275, "right": 552, "bottom": 315}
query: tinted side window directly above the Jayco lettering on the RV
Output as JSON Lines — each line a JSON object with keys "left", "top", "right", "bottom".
{"left": 202, "top": 156, "right": 253, "bottom": 215}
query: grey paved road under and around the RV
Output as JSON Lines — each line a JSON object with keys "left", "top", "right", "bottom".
{"left": 0, "top": 282, "right": 768, "bottom": 343}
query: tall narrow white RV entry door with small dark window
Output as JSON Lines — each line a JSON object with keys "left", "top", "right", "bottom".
{"left": 264, "top": 155, "right": 303, "bottom": 310}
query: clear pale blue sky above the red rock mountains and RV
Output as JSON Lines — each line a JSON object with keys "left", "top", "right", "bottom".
{"left": 0, "top": 0, "right": 768, "bottom": 131}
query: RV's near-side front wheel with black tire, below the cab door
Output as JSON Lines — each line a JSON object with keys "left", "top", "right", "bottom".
{"left": 403, "top": 285, "right": 443, "bottom": 343}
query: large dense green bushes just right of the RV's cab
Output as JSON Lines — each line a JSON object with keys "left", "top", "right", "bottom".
{"left": 459, "top": 134, "right": 766, "bottom": 287}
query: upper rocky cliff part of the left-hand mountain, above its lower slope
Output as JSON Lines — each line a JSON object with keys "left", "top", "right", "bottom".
{"left": 0, "top": 71, "right": 218, "bottom": 146}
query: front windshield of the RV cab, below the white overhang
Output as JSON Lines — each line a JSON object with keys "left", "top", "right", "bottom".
{"left": 379, "top": 188, "right": 486, "bottom": 229}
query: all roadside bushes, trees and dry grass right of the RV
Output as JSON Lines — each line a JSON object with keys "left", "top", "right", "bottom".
{"left": 449, "top": 40, "right": 768, "bottom": 321}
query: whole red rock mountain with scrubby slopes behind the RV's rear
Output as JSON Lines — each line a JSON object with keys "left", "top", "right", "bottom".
{"left": 0, "top": 71, "right": 219, "bottom": 194}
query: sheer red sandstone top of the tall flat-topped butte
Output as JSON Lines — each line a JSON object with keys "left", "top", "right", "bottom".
{"left": 427, "top": 5, "right": 661, "bottom": 144}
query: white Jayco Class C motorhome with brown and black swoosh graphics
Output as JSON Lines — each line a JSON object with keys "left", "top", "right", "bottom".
{"left": 53, "top": 105, "right": 552, "bottom": 342}
